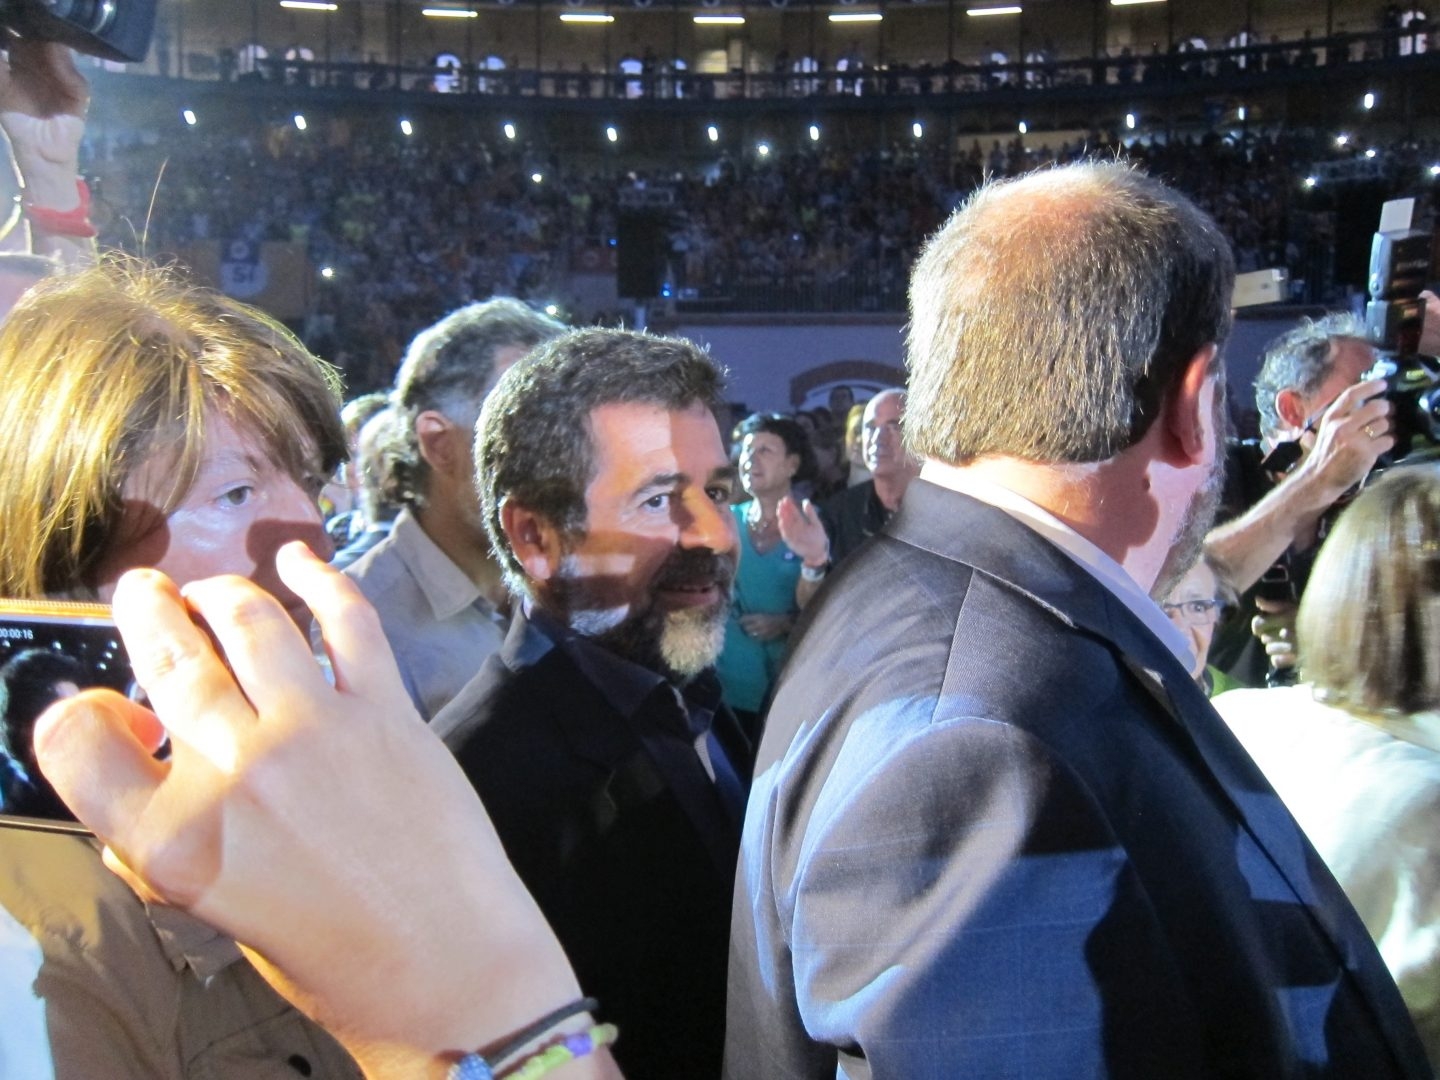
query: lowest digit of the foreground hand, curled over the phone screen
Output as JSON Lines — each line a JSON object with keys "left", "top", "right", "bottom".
{"left": 35, "top": 690, "right": 170, "bottom": 850}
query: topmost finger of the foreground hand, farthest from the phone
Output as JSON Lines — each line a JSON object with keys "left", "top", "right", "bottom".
{"left": 275, "top": 541, "right": 409, "bottom": 704}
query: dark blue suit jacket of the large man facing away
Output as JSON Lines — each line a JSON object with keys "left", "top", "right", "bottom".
{"left": 726, "top": 481, "right": 1430, "bottom": 1080}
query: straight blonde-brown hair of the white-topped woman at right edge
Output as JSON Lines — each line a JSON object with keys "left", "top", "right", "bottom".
{"left": 1296, "top": 464, "right": 1440, "bottom": 716}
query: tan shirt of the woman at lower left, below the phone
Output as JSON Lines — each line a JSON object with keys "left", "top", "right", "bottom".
{"left": 0, "top": 828, "right": 361, "bottom": 1080}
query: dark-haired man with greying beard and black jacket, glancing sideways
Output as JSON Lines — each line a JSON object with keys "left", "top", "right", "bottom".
{"left": 435, "top": 330, "right": 750, "bottom": 1080}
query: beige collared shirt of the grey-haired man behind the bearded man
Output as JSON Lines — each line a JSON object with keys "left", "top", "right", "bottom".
{"left": 346, "top": 510, "right": 507, "bottom": 720}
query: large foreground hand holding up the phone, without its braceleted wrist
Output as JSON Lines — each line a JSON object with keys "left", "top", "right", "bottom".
{"left": 36, "top": 544, "right": 579, "bottom": 1064}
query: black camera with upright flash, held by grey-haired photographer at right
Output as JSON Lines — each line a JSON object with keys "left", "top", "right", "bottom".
{"left": 1365, "top": 221, "right": 1440, "bottom": 467}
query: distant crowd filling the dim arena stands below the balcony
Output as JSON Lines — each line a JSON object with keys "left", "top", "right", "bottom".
{"left": 88, "top": 120, "right": 1436, "bottom": 390}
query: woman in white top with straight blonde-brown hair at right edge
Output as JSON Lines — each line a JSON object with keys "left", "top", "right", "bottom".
{"left": 1215, "top": 464, "right": 1440, "bottom": 1064}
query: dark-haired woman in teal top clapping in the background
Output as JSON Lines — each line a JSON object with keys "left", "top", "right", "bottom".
{"left": 716, "top": 413, "right": 829, "bottom": 736}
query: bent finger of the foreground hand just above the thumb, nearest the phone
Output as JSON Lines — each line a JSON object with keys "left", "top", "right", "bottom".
{"left": 112, "top": 570, "right": 262, "bottom": 763}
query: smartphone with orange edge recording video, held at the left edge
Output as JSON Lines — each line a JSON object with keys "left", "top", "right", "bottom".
{"left": 0, "top": 599, "right": 138, "bottom": 832}
